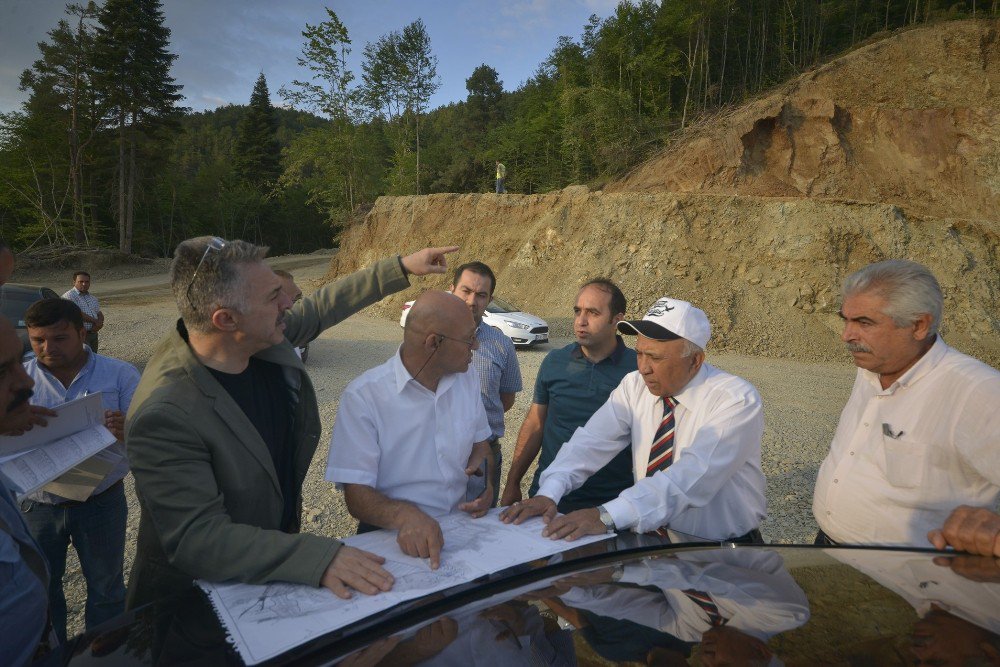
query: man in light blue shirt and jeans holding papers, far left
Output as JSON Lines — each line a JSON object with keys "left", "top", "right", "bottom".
{"left": 21, "top": 299, "right": 139, "bottom": 641}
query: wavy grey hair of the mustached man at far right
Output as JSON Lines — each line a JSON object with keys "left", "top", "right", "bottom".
{"left": 843, "top": 259, "right": 944, "bottom": 335}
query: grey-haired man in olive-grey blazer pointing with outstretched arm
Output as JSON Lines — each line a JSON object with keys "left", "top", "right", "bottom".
{"left": 125, "top": 237, "right": 457, "bottom": 608}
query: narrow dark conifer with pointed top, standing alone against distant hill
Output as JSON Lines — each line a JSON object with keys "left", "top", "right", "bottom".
{"left": 233, "top": 72, "right": 281, "bottom": 189}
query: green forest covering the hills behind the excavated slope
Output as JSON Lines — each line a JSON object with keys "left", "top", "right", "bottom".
{"left": 0, "top": 0, "right": 1000, "bottom": 256}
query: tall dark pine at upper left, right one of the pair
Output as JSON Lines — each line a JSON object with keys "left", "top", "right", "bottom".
{"left": 95, "top": 0, "right": 184, "bottom": 252}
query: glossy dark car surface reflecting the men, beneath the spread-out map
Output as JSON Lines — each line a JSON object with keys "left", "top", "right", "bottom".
{"left": 64, "top": 534, "right": 1000, "bottom": 665}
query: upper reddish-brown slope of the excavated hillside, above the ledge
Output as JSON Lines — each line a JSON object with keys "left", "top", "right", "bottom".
{"left": 607, "top": 20, "right": 1000, "bottom": 222}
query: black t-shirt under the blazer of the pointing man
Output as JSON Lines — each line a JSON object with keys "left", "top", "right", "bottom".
{"left": 208, "top": 357, "right": 297, "bottom": 530}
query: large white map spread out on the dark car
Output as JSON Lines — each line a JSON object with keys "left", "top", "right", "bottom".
{"left": 198, "top": 509, "right": 610, "bottom": 664}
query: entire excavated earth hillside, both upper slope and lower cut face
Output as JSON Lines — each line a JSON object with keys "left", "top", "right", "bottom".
{"left": 330, "top": 21, "right": 1000, "bottom": 366}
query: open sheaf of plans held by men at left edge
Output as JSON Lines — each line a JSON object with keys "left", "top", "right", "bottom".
{"left": 0, "top": 394, "right": 121, "bottom": 501}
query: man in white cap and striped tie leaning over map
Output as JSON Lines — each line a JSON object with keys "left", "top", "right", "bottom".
{"left": 501, "top": 297, "right": 767, "bottom": 542}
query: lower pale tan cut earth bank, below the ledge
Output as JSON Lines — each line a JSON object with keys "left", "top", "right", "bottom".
{"left": 328, "top": 188, "right": 1000, "bottom": 365}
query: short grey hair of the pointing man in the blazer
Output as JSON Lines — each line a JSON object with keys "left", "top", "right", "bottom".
{"left": 170, "top": 236, "right": 268, "bottom": 333}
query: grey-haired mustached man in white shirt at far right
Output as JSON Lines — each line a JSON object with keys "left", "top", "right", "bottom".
{"left": 813, "top": 260, "right": 1000, "bottom": 556}
